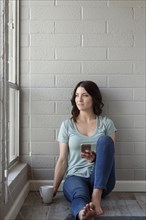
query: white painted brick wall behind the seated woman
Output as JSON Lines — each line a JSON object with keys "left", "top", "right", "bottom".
{"left": 20, "top": 0, "right": 146, "bottom": 180}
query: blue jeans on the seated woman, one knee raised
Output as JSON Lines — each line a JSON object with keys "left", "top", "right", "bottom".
{"left": 63, "top": 135, "right": 115, "bottom": 218}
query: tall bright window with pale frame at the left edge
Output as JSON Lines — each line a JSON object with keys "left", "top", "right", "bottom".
{"left": 8, "top": 0, "right": 20, "bottom": 164}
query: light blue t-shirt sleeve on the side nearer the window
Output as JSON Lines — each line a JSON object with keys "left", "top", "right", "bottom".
{"left": 57, "top": 120, "right": 69, "bottom": 143}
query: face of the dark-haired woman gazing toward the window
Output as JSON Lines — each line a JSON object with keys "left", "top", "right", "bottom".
{"left": 75, "top": 87, "right": 93, "bottom": 111}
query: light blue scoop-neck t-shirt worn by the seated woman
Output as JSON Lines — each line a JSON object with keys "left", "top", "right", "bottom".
{"left": 58, "top": 116, "right": 117, "bottom": 178}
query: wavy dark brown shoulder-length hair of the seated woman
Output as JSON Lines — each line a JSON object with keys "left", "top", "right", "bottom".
{"left": 71, "top": 80, "right": 104, "bottom": 121}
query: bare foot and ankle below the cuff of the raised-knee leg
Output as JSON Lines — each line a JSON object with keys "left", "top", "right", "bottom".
{"left": 92, "top": 189, "right": 103, "bottom": 215}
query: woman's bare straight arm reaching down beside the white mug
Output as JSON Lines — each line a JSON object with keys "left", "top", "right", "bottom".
{"left": 54, "top": 143, "right": 68, "bottom": 196}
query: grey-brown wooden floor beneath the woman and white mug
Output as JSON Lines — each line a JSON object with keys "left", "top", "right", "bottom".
{"left": 16, "top": 192, "right": 146, "bottom": 220}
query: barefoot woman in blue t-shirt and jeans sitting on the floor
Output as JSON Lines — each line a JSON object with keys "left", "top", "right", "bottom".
{"left": 54, "top": 81, "right": 116, "bottom": 220}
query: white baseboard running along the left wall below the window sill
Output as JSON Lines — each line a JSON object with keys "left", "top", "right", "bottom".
{"left": 4, "top": 181, "right": 30, "bottom": 220}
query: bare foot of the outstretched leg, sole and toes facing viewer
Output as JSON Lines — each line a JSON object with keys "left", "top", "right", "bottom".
{"left": 78, "top": 202, "right": 96, "bottom": 220}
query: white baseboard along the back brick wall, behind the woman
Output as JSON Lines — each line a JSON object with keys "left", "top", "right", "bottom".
{"left": 30, "top": 180, "right": 146, "bottom": 192}
